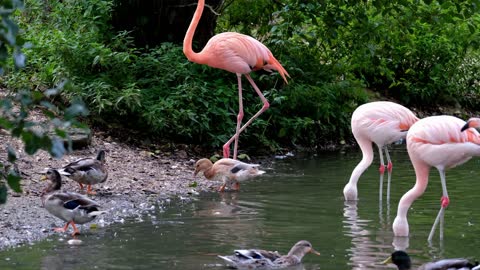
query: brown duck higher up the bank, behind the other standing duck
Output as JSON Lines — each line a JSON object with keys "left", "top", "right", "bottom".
{"left": 59, "top": 150, "right": 108, "bottom": 194}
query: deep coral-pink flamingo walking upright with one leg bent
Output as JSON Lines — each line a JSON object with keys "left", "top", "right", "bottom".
{"left": 183, "top": 0, "right": 290, "bottom": 159}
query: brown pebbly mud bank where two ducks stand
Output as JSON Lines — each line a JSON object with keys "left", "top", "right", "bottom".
{"left": 0, "top": 134, "right": 223, "bottom": 250}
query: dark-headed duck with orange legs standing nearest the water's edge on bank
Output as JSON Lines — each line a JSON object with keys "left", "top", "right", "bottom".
{"left": 42, "top": 169, "right": 105, "bottom": 235}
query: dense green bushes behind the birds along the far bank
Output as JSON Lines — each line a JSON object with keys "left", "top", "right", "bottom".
{"left": 2, "top": 0, "right": 480, "bottom": 156}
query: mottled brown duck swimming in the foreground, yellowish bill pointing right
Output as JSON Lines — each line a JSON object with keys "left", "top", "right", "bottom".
{"left": 218, "top": 240, "right": 320, "bottom": 269}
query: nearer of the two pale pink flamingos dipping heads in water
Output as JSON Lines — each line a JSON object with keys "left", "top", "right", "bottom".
{"left": 393, "top": 115, "right": 480, "bottom": 242}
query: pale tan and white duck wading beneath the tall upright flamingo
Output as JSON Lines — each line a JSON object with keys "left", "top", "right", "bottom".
{"left": 193, "top": 158, "right": 265, "bottom": 191}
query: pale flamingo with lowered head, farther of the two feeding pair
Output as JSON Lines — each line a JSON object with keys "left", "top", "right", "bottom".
{"left": 343, "top": 101, "right": 418, "bottom": 201}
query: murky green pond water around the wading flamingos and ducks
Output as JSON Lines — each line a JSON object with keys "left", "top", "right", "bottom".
{"left": 0, "top": 145, "right": 480, "bottom": 270}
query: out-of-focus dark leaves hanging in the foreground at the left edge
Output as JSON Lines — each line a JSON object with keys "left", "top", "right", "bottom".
{"left": 0, "top": 0, "right": 86, "bottom": 204}
